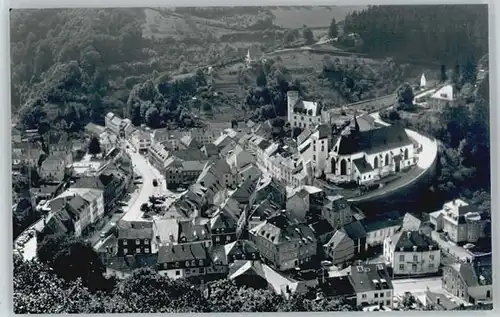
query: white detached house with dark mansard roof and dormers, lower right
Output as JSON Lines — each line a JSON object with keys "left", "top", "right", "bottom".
{"left": 384, "top": 231, "right": 441, "bottom": 276}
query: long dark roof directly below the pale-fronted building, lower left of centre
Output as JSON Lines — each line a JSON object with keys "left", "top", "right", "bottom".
{"left": 158, "top": 243, "right": 207, "bottom": 263}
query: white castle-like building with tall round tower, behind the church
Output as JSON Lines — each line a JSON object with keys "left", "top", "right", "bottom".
{"left": 287, "top": 90, "right": 323, "bottom": 128}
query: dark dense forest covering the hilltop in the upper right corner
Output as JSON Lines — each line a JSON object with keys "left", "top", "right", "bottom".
{"left": 344, "top": 4, "right": 488, "bottom": 66}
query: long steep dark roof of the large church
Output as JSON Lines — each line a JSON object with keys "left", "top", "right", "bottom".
{"left": 338, "top": 125, "right": 412, "bottom": 155}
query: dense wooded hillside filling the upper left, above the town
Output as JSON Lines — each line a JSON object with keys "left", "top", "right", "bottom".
{"left": 11, "top": 8, "right": 236, "bottom": 133}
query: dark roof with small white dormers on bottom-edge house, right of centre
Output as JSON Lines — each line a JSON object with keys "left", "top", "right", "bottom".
{"left": 349, "top": 264, "right": 393, "bottom": 293}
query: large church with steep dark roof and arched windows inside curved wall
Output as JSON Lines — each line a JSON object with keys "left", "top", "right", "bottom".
{"left": 325, "top": 119, "right": 417, "bottom": 184}
